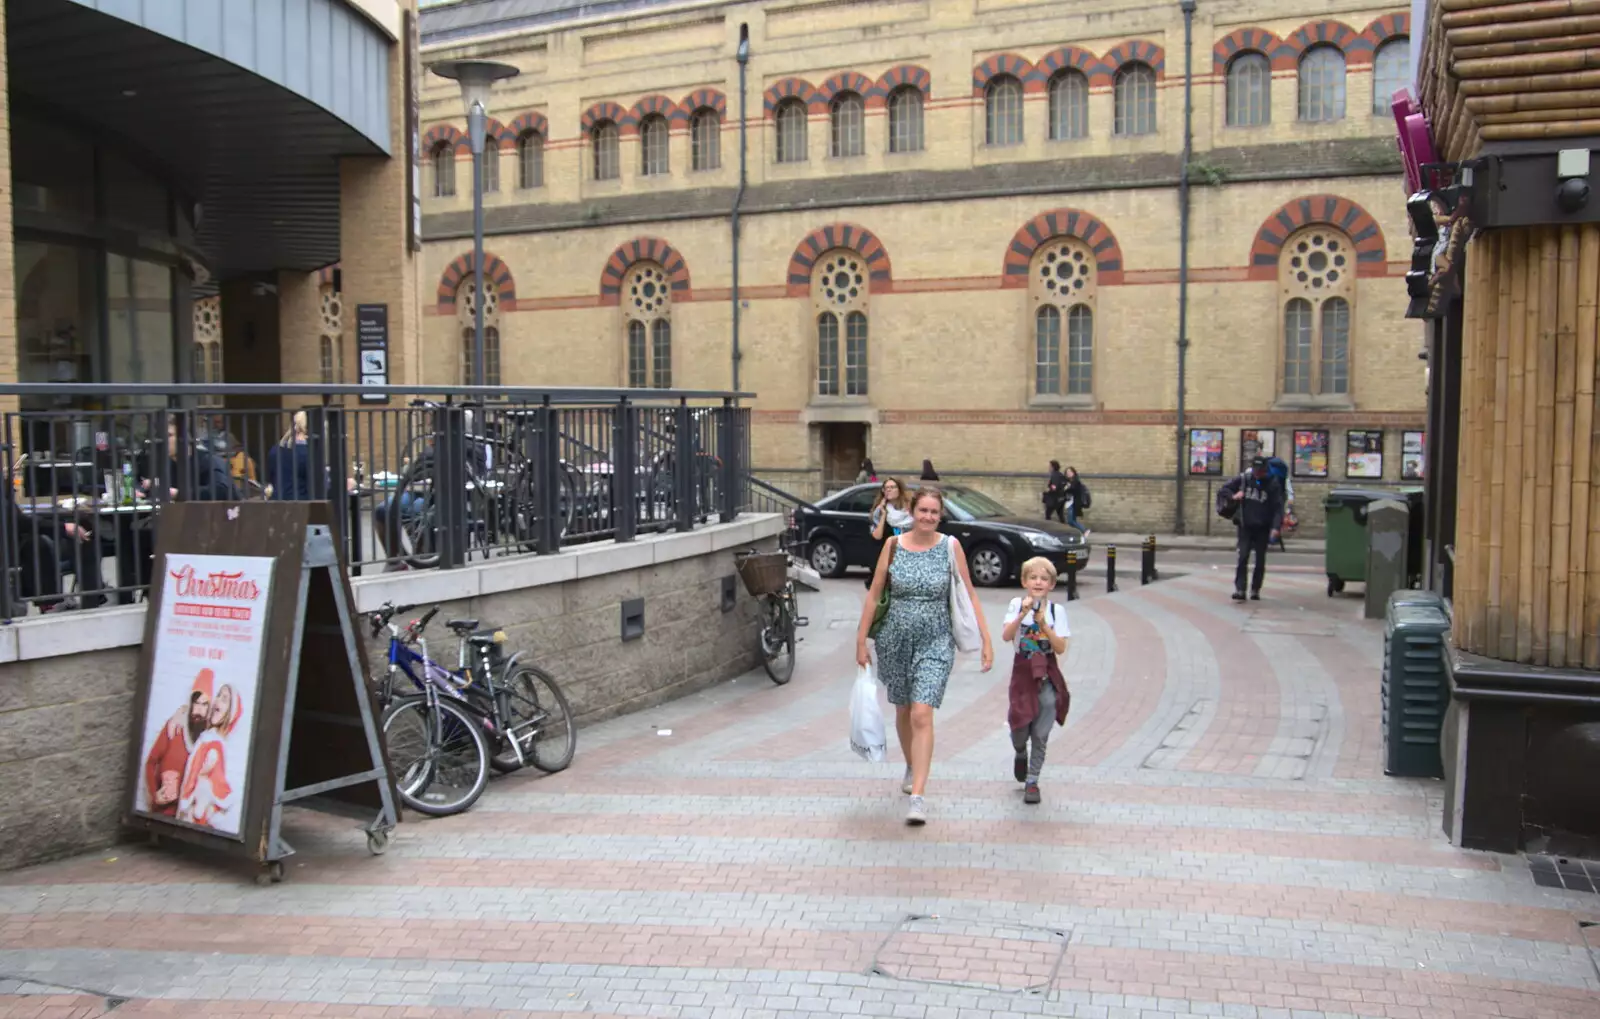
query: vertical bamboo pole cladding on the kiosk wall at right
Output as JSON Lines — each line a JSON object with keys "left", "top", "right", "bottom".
{"left": 1454, "top": 226, "right": 1600, "bottom": 669}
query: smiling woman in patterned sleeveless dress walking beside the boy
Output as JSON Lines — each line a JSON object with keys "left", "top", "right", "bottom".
{"left": 856, "top": 488, "right": 995, "bottom": 825}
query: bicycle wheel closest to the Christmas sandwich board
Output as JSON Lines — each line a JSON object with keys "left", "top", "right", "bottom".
{"left": 384, "top": 697, "right": 490, "bottom": 817}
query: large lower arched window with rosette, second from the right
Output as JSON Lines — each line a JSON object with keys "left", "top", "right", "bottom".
{"left": 1029, "top": 237, "right": 1096, "bottom": 397}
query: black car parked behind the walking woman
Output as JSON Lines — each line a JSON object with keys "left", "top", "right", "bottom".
{"left": 794, "top": 483, "right": 1088, "bottom": 587}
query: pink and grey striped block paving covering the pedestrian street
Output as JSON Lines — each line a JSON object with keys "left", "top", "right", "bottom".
{"left": 0, "top": 565, "right": 1600, "bottom": 1019}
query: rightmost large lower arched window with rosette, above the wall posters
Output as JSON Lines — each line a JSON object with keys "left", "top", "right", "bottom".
{"left": 1278, "top": 226, "right": 1355, "bottom": 398}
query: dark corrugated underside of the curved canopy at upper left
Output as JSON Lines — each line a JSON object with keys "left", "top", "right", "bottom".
{"left": 6, "top": 0, "right": 382, "bottom": 278}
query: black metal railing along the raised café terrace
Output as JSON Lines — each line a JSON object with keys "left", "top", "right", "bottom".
{"left": 0, "top": 384, "right": 750, "bottom": 619}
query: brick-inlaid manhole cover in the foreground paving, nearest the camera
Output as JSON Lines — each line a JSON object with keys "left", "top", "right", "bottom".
{"left": 872, "top": 915, "right": 1072, "bottom": 993}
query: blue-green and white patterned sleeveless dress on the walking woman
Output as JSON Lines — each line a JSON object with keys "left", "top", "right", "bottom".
{"left": 877, "top": 536, "right": 955, "bottom": 707}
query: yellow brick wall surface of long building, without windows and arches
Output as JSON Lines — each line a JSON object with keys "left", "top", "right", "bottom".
{"left": 421, "top": 0, "right": 1426, "bottom": 529}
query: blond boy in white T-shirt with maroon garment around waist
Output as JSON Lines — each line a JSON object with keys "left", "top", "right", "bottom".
{"left": 1000, "top": 555, "right": 1072, "bottom": 803}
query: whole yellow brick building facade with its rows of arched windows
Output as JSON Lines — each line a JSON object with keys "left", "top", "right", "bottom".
{"left": 421, "top": 0, "right": 1426, "bottom": 531}
